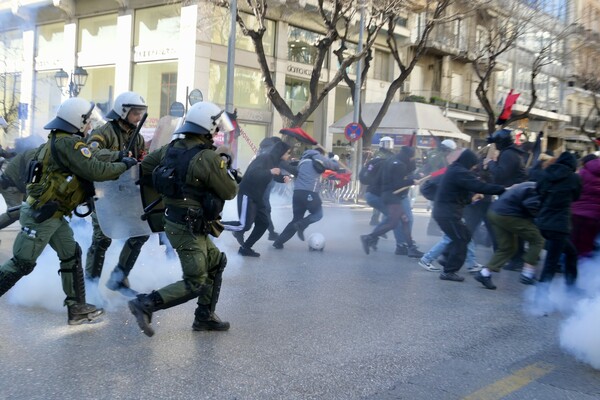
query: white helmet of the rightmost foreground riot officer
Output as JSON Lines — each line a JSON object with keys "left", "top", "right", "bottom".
{"left": 174, "top": 101, "right": 233, "bottom": 135}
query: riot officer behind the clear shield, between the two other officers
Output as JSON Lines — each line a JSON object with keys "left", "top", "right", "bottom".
{"left": 85, "top": 92, "right": 148, "bottom": 297}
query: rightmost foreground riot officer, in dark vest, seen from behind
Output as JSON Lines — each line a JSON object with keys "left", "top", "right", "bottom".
{"left": 129, "top": 102, "right": 237, "bottom": 336}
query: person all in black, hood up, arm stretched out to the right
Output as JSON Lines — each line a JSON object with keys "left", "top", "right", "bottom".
{"left": 433, "top": 149, "right": 505, "bottom": 282}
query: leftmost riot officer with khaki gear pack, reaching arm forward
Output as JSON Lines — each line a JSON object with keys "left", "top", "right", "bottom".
{"left": 0, "top": 98, "right": 137, "bottom": 325}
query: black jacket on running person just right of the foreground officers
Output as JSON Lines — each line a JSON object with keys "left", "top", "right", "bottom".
{"left": 239, "top": 142, "right": 290, "bottom": 205}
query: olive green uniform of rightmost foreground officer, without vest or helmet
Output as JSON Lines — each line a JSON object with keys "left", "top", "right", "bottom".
{"left": 129, "top": 135, "right": 237, "bottom": 336}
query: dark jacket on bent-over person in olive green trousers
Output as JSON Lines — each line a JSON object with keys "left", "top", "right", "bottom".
{"left": 491, "top": 182, "right": 541, "bottom": 219}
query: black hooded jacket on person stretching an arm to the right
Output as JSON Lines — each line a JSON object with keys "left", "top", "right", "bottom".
{"left": 433, "top": 149, "right": 505, "bottom": 220}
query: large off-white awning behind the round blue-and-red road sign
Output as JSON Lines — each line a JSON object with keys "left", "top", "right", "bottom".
{"left": 329, "top": 101, "right": 471, "bottom": 142}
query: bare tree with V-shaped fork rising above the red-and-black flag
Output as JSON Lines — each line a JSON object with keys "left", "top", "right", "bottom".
{"left": 227, "top": 0, "right": 393, "bottom": 127}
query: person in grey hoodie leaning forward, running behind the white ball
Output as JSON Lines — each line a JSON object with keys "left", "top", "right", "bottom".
{"left": 273, "top": 148, "right": 339, "bottom": 249}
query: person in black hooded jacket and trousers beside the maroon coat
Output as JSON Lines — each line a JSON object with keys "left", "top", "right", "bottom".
{"left": 536, "top": 151, "right": 581, "bottom": 286}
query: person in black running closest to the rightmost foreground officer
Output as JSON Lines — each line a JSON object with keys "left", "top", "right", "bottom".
{"left": 223, "top": 141, "right": 291, "bottom": 257}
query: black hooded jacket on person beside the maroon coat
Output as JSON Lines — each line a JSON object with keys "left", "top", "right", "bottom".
{"left": 536, "top": 152, "right": 581, "bottom": 233}
